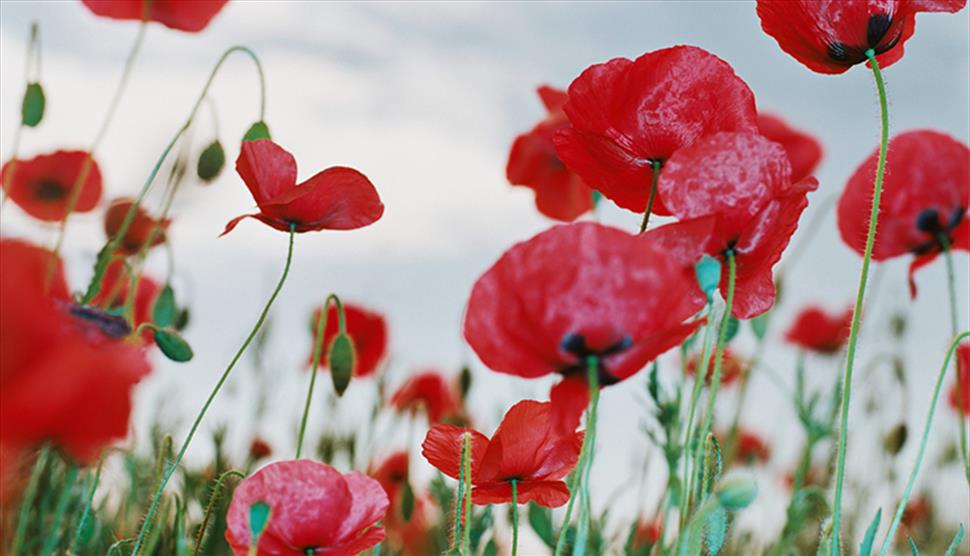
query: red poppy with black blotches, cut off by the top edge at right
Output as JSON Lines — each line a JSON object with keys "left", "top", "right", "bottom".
{"left": 758, "top": 0, "right": 967, "bottom": 74}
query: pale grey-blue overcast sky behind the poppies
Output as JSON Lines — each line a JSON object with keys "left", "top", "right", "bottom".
{"left": 0, "top": 1, "right": 970, "bottom": 552}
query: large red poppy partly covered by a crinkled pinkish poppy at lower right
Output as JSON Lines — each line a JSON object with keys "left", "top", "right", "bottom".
{"left": 555, "top": 46, "right": 757, "bottom": 215}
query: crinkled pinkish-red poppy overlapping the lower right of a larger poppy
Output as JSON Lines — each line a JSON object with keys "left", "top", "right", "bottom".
{"left": 647, "top": 133, "right": 818, "bottom": 319}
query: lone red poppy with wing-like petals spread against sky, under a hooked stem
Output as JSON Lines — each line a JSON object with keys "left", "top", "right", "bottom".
{"left": 222, "top": 139, "right": 384, "bottom": 235}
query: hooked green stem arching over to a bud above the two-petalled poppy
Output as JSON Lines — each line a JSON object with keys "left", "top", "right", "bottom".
{"left": 81, "top": 46, "right": 266, "bottom": 304}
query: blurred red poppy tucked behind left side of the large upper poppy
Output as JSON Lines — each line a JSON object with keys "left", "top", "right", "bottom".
{"left": 505, "top": 85, "right": 594, "bottom": 222}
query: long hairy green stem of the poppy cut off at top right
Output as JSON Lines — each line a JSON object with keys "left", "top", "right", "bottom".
{"left": 830, "top": 49, "right": 889, "bottom": 556}
